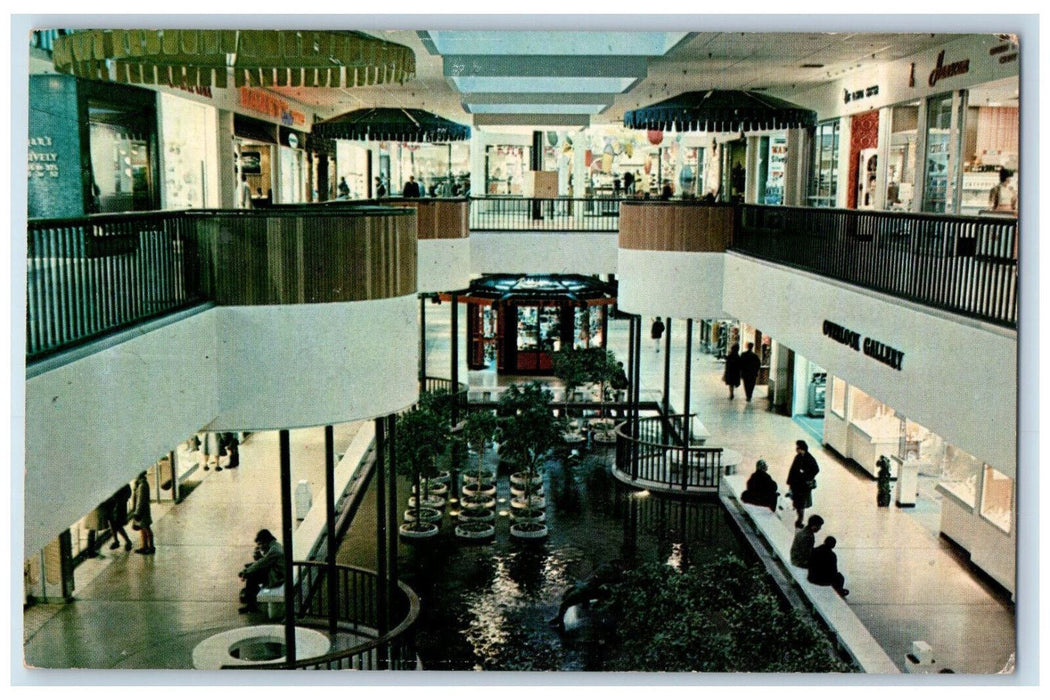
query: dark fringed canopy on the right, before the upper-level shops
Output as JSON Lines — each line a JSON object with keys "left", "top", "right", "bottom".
{"left": 624, "top": 90, "right": 817, "bottom": 133}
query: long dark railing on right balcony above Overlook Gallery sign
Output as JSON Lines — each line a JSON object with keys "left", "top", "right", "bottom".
{"left": 732, "top": 205, "right": 1017, "bottom": 327}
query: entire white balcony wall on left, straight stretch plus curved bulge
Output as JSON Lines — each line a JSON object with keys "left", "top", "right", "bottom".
{"left": 24, "top": 294, "right": 419, "bottom": 552}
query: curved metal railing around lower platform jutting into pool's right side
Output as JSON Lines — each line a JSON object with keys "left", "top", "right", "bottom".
{"left": 616, "top": 415, "right": 722, "bottom": 491}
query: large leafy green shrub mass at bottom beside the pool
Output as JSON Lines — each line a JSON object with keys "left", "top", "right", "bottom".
{"left": 597, "top": 555, "right": 853, "bottom": 673}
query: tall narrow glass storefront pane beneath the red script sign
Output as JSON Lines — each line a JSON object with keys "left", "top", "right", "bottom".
{"left": 922, "top": 94, "right": 962, "bottom": 214}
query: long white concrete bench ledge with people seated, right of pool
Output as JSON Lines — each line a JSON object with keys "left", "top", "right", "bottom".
{"left": 721, "top": 474, "right": 901, "bottom": 674}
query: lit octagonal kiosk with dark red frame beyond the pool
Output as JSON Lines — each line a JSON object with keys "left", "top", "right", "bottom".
{"left": 453, "top": 275, "right": 616, "bottom": 375}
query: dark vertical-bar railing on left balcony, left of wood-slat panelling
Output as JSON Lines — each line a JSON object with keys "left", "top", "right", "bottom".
{"left": 25, "top": 212, "right": 203, "bottom": 360}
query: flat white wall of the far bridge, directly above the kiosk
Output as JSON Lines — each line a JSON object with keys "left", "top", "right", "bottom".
{"left": 470, "top": 231, "right": 616, "bottom": 276}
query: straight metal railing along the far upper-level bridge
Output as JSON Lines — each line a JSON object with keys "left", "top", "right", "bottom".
{"left": 470, "top": 197, "right": 622, "bottom": 233}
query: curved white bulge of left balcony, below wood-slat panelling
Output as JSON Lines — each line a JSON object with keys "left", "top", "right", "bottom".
{"left": 207, "top": 295, "right": 419, "bottom": 430}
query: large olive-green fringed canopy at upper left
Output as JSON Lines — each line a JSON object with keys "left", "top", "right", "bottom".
{"left": 53, "top": 29, "right": 416, "bottom": 87}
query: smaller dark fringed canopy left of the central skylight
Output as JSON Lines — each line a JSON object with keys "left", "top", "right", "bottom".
{"left": 313, "top": 107, "right": 470, "bottom": 143}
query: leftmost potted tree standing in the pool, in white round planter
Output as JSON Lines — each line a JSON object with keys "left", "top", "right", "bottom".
{"left": 396, "top": 395, "right": 450, "bottom": 538}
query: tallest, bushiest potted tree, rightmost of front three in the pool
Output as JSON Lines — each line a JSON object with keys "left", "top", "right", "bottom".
{"left": 498, "top": 382, "right": 564, "bottom": 538}
